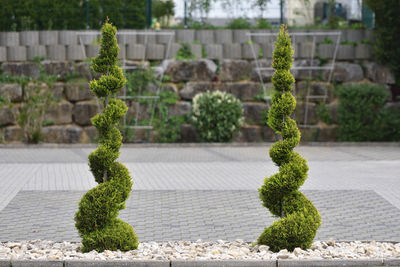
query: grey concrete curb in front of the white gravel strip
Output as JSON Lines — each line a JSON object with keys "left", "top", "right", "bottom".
{"left": 0, "top": 259, "right": 400, "bottom": 267}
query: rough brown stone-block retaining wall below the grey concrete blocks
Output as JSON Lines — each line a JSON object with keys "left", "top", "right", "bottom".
{"left": 0, "top": 59, "right": 394, "bottom": 143}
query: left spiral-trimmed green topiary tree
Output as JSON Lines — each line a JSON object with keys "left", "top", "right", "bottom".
{"left": 75, "top": 20, "right": 138, "bottom": 252}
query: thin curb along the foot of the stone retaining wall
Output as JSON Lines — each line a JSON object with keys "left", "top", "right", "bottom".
{"left": 0, "top": 142, "right": 400, "bottom": 149}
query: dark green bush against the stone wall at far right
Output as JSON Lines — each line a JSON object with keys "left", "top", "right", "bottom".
{"left": 337, "top": 84, "right": 400, "bottom": 141}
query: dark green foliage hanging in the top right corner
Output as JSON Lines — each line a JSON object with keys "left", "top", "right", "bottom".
{"left": 365, "top": 0, "right": 400, "bottom": 84}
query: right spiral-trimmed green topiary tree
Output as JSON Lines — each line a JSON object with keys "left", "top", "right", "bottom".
{"left": 258, "top": 25, "right": 321, "bottom": 252}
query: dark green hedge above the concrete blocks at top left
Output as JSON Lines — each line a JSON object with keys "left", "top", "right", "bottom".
{"left": 0, "top": 0, "right": 145, "bottom": 31}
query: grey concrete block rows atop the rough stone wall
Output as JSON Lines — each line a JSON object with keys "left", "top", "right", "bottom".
{"left": 0, "top": 29, "right": 373, "bottom": 62}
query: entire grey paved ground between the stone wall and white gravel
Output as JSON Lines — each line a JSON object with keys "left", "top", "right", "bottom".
{"left": 0, "top": 144, "right": 400, "bottom": 242}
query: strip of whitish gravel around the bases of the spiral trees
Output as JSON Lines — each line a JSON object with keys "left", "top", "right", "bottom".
{"left": 0, "top": 239, "right": 400, "bottom": 260}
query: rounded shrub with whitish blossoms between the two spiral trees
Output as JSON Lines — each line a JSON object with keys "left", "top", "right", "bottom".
{"left": 191, "top": 91, "right": 243, "bottom": 142}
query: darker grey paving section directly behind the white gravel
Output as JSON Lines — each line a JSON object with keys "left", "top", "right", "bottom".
{"left": 0, "top": 190, "right": 400, "bottom": 242}
